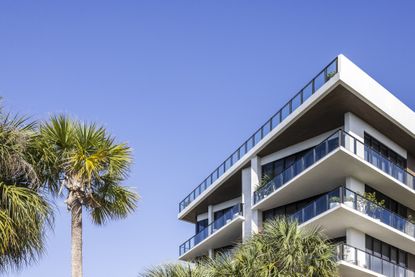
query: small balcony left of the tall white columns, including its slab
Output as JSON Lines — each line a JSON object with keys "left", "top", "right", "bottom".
{"left": 179, "top": 204, "right": 244, "bottom": 260}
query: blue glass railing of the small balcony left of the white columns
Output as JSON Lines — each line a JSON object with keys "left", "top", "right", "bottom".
{"left": 179, "top": 204, "right": 243, "bottom": 256}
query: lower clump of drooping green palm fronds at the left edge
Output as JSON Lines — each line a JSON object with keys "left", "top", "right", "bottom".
{"left": 0, "top": 182, "right": 53, "bottom": 270}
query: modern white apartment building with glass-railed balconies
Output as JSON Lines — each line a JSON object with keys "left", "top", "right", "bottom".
{"left": 178, "top": 55, "right": 415, "bottom": 276}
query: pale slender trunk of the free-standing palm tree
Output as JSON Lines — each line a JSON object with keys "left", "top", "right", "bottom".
{"left": 71, "top": 201, "right": 82, "bottom": 277}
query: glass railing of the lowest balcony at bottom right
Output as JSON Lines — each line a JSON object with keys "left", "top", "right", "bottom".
{"left": 336, "top": 244, "right": 415, "bottom": 277}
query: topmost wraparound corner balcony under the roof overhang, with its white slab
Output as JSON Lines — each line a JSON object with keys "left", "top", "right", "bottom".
{"left": 254, "top": 130, "right": 415, "bottom": 209}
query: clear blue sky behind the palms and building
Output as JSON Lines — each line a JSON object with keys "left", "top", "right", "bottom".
{"left": 0, "top": 0, "right": 415, "bottom": 277}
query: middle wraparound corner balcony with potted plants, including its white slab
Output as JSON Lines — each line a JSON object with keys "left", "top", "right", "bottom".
{"left": 290, "top": 186, "right": 415, "bottom": 254}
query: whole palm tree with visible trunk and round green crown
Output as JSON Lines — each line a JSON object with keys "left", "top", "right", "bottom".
{"left": 36, "top": 115, "right": 138, "bottom": 277}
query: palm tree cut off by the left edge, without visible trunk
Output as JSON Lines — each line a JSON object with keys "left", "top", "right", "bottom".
{"left": 0, "top": 109, "right": 53, "bottom": 272}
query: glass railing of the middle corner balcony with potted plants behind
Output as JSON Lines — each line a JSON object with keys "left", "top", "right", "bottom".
{"left": 290, "top": 186, "right": 415, "bottom": 238}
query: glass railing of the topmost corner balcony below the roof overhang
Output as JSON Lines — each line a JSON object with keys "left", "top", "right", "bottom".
{"left": 254, "top": 130, "right": 415, "bottom": 204}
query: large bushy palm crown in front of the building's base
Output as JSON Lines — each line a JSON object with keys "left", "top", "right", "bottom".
{"left": 231, "top": 217, "right": 337, "bottom": 277}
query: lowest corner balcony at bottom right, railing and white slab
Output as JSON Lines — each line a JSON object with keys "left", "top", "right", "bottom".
{"left": 336, "top": 244, "right": 415, "bottom": 277}
